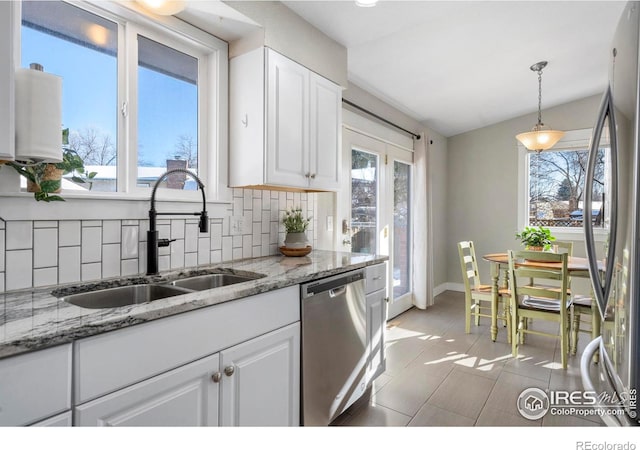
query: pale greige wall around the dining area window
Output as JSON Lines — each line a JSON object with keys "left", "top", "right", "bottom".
{"left": 445, "top": 95, "right": 600, "bottom": 283}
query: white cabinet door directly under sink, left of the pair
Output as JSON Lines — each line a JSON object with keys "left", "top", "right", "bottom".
{"left": 75, "top": 353, "right": 220, "bottom": 426}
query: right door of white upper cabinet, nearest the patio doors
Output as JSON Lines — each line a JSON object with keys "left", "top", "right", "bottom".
{"left": 309, "top": 73, "right": 342, "bottom": 190}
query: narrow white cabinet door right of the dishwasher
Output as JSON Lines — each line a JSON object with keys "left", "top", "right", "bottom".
{"left": 367, "top": 289, "right": 387, "bottom": 382}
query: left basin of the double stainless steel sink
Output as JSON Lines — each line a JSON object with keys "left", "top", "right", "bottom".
{"left": 61, "top": 284, "right": 191, "bottom": 309}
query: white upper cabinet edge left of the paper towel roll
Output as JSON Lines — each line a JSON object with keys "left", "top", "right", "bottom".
{"left": 0, "top": 2, "right": 19, "bottom": 160}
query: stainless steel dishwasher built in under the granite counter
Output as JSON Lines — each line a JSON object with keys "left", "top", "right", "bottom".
{"left": 301, "top": 269, "right": 367, "bottom": 426}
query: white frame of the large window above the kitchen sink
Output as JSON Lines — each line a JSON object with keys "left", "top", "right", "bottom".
{"left": 7, "top": 0, "right": 231, "bottom": 203}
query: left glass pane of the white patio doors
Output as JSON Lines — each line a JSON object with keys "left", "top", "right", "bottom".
{"left": 351, "top": 149, "right": 379, "bottom": 253}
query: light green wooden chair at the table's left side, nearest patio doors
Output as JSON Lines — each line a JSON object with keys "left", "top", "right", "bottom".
{"left": 458, "top": 241, "right": 511, "bottom": 340}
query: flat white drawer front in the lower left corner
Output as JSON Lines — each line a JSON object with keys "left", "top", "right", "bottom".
{"left": 0, "top": 344, "right": 71, "bottom": 426}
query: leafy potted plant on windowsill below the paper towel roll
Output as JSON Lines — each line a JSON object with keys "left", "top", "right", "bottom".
{"left": 7, "top": 128, "right": 96, "bottom": 202}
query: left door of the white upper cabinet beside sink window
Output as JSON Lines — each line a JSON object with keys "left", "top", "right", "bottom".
{"left": 265, "top": 50, "right": 309, "bottom": 188}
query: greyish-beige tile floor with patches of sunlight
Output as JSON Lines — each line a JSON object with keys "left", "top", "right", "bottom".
{"left": 333, "top": 291, "right": 601, "bottom": 427}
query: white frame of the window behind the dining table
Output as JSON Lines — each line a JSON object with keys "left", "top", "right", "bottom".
{"left": 518, "top": 128, "right": 609, "bottom": 242}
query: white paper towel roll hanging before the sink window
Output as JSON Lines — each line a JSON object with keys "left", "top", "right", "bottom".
{"left": 15, "top": 69, "right": 62, "bottom": 162}
